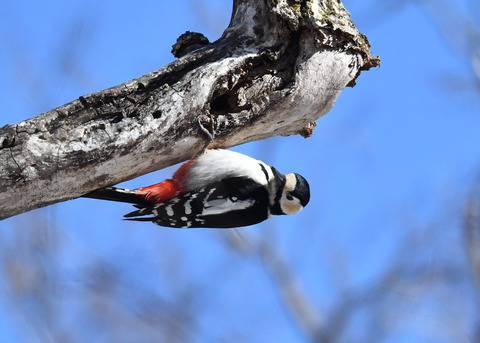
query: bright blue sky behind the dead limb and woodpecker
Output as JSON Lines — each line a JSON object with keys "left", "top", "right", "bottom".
{"left": 0, "top": 0, "right": 480, "bottom": 342}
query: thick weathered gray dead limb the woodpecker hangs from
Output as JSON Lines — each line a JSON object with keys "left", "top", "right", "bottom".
{"left": 0, "top": 0, "right": 379, "bottom": 219}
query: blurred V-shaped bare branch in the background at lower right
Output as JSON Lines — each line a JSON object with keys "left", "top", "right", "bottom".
{"left": 221, "top": 211, "right": 470, "bottom": 343}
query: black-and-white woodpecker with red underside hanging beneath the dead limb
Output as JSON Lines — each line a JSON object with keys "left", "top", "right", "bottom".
{"left": 84, "top": 150, "right": 310, "bottom": 228}
